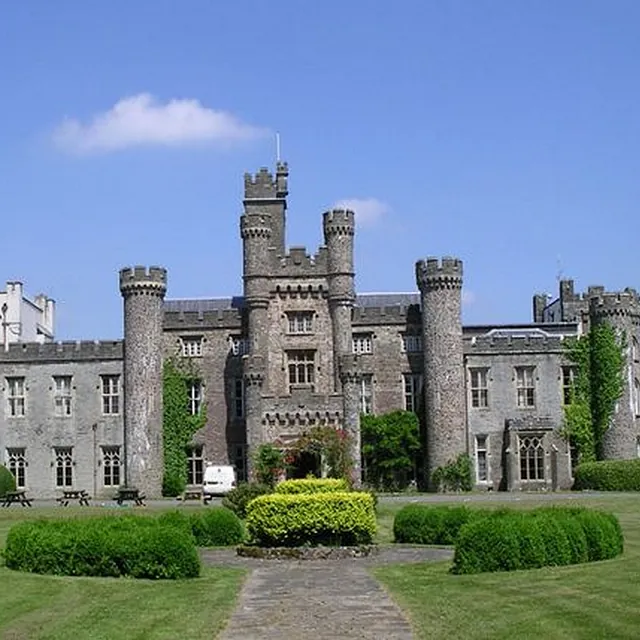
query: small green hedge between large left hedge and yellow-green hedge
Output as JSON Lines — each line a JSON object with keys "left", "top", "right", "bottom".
{"left": 158, "top": 507, "right": 244, "bottom": 547}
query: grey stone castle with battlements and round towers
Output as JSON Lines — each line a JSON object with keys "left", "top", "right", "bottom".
{"left": 0, "top": 163, "right": 640, "bottom": 498}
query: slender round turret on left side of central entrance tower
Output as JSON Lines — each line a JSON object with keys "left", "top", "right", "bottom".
{"left": 240, "top": 213, "right": 271, "bottom": 355}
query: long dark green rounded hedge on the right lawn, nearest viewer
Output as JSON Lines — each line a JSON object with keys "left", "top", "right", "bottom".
{"left": 451, "top": 507, "right": 624, "bottom": 573}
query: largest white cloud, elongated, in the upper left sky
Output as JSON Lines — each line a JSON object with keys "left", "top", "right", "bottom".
{"left": 53, "top": 93, "right": 267, "bottom": 154}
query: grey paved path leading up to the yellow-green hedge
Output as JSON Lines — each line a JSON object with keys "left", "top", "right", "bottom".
{"left": 203, "top": 547, "right": 451, "bottom": 640}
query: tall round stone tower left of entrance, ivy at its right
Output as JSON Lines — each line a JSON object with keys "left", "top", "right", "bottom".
{"left": 120, "top": 267, "right": 167, "bottom": 498}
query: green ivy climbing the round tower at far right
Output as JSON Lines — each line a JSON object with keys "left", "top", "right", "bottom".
{"left": 564, "top": 323, "right": 626, "bottom": 462}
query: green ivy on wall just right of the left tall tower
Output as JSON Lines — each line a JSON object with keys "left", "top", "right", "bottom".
{"left": 162, "top": 357, "right": 207, "bottom": 496}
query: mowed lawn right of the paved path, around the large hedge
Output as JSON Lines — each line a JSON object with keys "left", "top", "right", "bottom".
{"left": 372, "top": 494, "right": 640, "bottom": 640}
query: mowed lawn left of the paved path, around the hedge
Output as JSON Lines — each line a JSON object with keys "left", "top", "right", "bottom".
{"left": 0, "top": 507, "right": 246, "bottom": 640}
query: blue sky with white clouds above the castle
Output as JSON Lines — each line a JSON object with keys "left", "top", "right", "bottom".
{"left": 0, "top": 0, "right": 640, "bottom": 339}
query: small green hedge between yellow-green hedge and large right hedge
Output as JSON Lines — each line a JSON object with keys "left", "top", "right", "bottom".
{"left": 393, "top": 504, "right": 478, "bottom": 544}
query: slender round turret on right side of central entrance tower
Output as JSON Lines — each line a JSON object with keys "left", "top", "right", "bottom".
{"left": 322, "top": 209, "right": 356, "bottom": 391}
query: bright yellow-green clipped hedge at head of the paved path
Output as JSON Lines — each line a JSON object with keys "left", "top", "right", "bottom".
{"left": 246, "top": 491, "right": 376, "bottom": 547}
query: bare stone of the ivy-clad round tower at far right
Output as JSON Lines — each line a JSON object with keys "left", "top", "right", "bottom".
{"left": 589, "top": 289, "right": 640, "bottom": 460}
